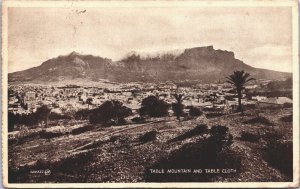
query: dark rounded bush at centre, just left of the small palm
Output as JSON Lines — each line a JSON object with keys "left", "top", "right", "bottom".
{"left": 139, "top": 96, "right": 169, "bottom": 117}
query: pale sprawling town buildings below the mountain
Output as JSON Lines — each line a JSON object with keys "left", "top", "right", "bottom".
{"left": 8, "top": 82, "right": 292, "bottom": 114}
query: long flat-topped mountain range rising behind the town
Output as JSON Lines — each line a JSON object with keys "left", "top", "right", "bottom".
{"left": 8, "top": 46, "right": 291, "bottom": 83}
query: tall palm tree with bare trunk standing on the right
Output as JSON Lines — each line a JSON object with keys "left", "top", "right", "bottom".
{"left": 226, "top": 70, "right": 255, "bottom": 114}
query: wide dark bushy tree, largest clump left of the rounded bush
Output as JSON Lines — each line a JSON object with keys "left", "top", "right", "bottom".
{"left": 89, "top": 100, "right": 132, "bottom": 125}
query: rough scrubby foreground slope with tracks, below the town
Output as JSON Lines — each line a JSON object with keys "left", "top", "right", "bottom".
{"left": 8, "top": 108, "right": 292, "bottom": 183}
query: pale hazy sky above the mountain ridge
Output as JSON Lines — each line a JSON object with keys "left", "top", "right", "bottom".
{"left": 8, "top": 7, "right": 292, "bottom": 72}
